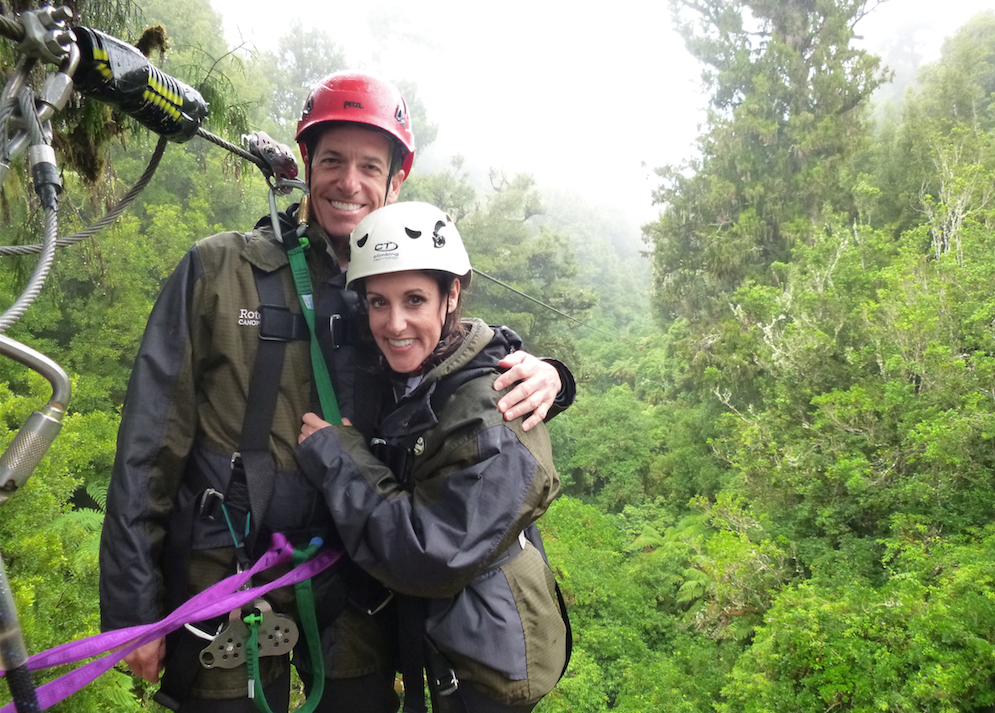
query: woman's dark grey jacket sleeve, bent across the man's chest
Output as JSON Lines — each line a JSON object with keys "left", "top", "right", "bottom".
{"left": 297, "top": 379, "right": 559, "bottom": 598}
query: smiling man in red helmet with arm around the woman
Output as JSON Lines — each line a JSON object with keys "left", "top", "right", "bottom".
{"left": 100, "top": 72, "right": 572, "bottom": 713}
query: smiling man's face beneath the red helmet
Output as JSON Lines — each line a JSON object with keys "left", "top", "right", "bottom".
{"left": 311, "top": 124, "right": 404, "bottom": 245}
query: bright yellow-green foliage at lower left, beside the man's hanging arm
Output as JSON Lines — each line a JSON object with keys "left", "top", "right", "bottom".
{"left": 0, "top": 376, "right": 139, "bottom": 711}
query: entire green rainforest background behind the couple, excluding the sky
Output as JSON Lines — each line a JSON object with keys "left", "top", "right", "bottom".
{"left": 0, "top": 0, "right": 995, "bottom": 713}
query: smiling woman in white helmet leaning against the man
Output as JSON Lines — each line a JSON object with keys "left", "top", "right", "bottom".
{"left": 297, "top": 203, "right": 568, "bottom": 713}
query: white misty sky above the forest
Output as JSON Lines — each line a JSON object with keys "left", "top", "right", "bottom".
{"left": 211, "top": 0, "right": 995, "bottom": 223}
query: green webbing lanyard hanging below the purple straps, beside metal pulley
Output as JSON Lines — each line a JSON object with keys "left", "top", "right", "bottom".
{"left": 243, "top": 537, "right": 325, "bottom": 713}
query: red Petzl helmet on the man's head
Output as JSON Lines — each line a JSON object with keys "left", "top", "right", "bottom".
{"left": 297, "top": 72, "right": 415, "bottom": 177}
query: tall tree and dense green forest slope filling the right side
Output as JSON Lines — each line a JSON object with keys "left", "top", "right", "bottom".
{"left": 624, "top": 2, "right": 995, "bottom": 712}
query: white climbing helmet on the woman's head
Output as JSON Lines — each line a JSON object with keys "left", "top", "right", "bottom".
{"left": 346, "top": 201, "right": 470, "bottom": 288}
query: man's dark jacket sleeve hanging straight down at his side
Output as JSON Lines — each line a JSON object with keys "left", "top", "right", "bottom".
{"left": 100, "top": 248, "right": 201, "bottom": 630}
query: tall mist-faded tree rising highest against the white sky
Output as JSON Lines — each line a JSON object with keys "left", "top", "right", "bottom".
{"left": 644, "top": 0, "right": 881, "bottom": 318}
